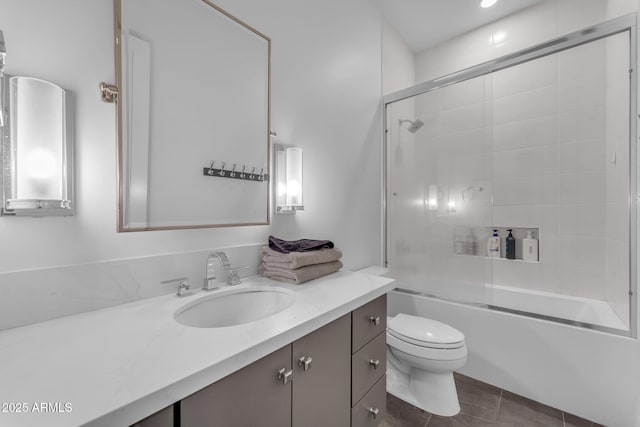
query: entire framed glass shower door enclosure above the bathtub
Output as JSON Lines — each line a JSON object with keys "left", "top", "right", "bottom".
{"left": 385, "top": 19, "right": 637, "bottom": 336}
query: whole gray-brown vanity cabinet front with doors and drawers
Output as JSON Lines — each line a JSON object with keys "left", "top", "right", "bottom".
{"left": 134, "top": 296, "right": 386, "bottom": 427}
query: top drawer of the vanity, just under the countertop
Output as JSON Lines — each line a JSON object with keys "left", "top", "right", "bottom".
{"left": 351, "top": 295, "right": 387, "bottom": 353}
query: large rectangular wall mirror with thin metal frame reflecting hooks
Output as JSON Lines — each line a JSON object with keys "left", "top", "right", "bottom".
{"left": 115, "top": 0, "right": 271, "bottom": 231}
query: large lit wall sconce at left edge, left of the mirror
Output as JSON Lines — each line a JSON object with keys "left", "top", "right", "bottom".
{"left": 0, "top": 75, "right": 73, "bottom": 216}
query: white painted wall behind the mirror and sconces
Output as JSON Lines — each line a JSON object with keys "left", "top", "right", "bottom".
{"left": 0, "top": 0, "right": 381, "bottom": 328}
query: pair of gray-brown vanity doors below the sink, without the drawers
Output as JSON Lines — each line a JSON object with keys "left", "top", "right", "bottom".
{"left": 180, "top": 314, "right": 351, "bottom": 427}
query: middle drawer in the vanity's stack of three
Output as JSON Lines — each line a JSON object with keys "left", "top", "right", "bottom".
{"left": 351, "top": 333, "right": 387, "bottom": 406}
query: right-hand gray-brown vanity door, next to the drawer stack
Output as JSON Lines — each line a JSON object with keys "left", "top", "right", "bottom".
{"left": 292, "top": 314, "right": 351, "bottom": 427}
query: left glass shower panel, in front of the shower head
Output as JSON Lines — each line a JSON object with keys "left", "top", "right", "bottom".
{"left": 387, "top": 76, "right": 492, "bottom": 304}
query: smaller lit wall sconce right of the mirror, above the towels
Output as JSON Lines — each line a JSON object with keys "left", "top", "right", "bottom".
{"left": 273, "top": 144, "right": 304, "bottom": 214}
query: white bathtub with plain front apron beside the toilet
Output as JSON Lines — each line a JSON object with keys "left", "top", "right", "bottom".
{"left": 388, "top": 280, "right": 640, "bottom": 427}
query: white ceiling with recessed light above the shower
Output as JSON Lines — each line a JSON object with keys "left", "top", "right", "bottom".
{"left": 380, "top": 0, "right": 542, "bottom": 52}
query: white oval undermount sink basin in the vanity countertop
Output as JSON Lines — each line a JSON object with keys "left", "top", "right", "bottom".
{"left": 174, "top": 287, "right": 295, "bottom": 328}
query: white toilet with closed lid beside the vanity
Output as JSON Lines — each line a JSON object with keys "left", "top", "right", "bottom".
{"left": 387, "top": 313, "right": 467, "bottom": 416}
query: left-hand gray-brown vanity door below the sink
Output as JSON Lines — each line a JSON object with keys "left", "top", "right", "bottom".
{"left": 180, "top": 345, "right": 291, "bottom": 427}
